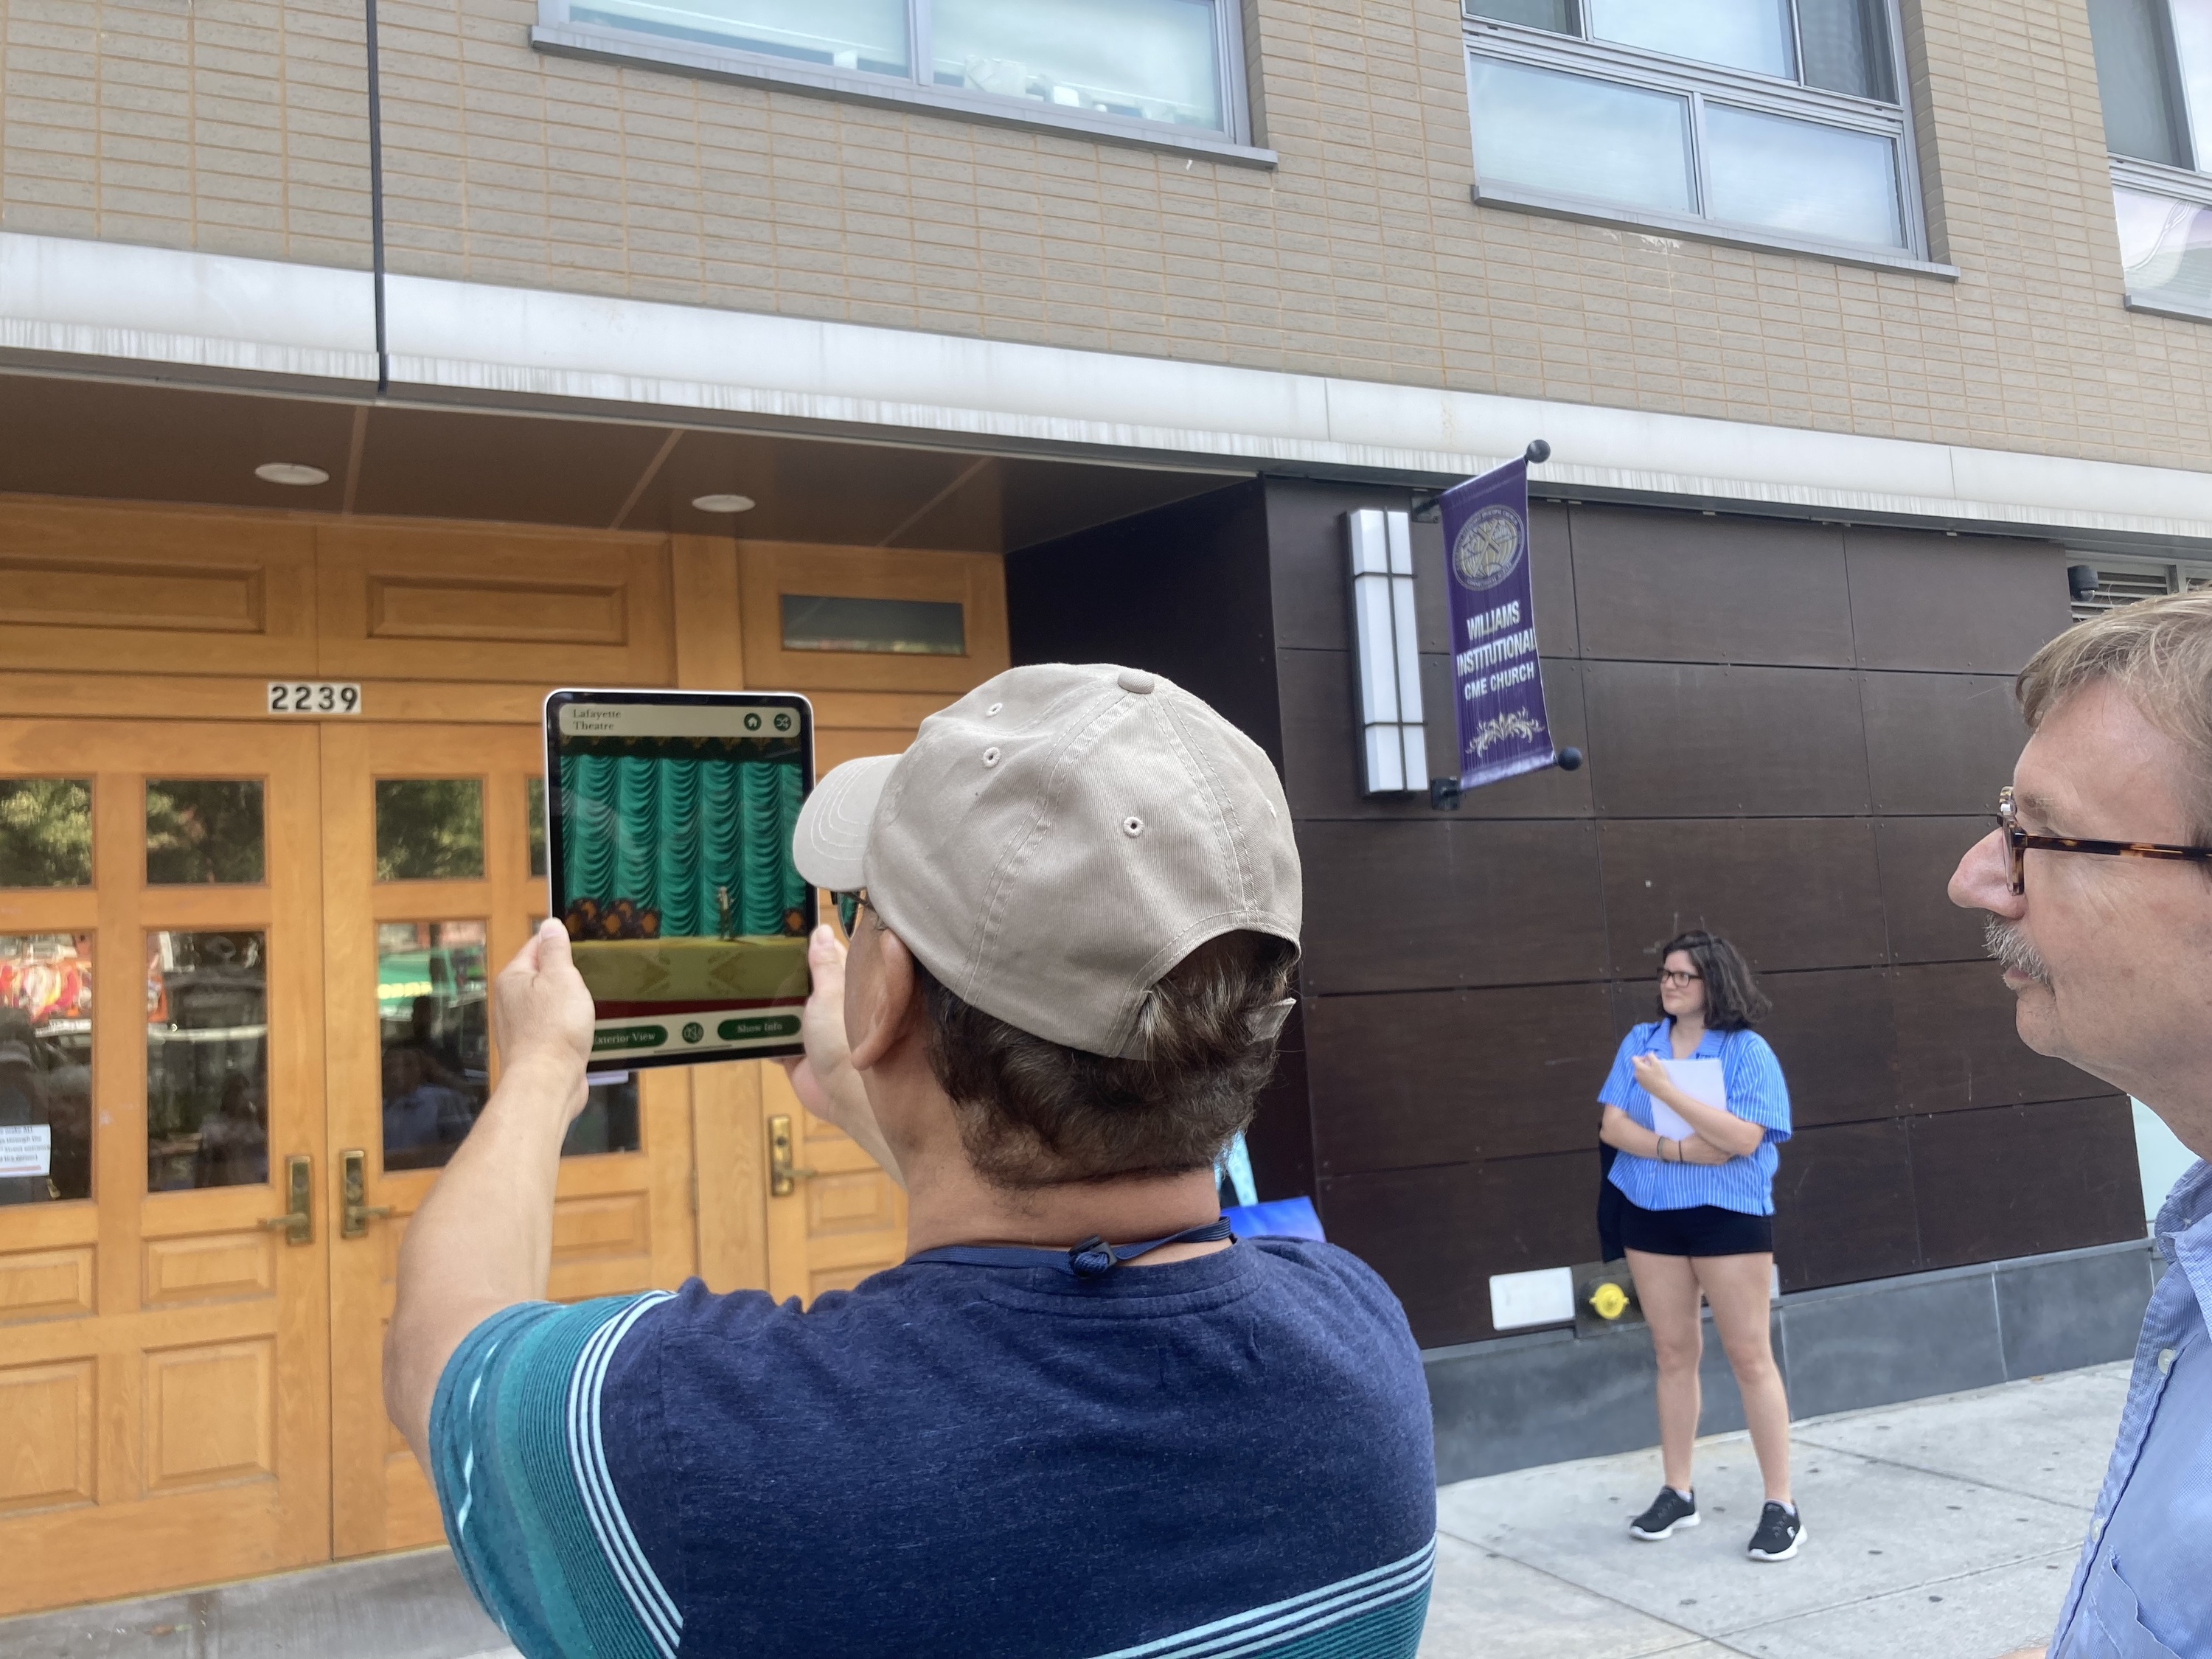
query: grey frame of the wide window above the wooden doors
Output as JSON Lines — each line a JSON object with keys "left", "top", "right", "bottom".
{"left": 531, "top": 0, "right": 1276, "bottom": 168}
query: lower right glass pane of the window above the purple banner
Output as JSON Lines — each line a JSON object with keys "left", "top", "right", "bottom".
{"left": 1705, "top": 104, "right": 1905, "bottom": 248}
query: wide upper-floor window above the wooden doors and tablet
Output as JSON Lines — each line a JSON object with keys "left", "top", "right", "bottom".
{"left": 533, "top": 0, "right": 1245, "bottom": 148}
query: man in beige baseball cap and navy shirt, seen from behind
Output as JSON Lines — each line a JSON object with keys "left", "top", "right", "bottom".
{"left": 387, "top": 664, "right": 1436, "bottom": 1659}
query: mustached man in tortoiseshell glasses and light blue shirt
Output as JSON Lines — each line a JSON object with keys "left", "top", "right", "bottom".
{"left": 1951, "top": 593, "right": 2212, "bottom": 1659}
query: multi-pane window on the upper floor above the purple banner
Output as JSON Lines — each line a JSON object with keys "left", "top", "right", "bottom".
{"left": 1467, "top": 0, "right": 1938, "bottom": 265}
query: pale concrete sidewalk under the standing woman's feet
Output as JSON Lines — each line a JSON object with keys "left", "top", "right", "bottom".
{"left": 1420, "top": 1365, "right": 2128, "bottom": 1659}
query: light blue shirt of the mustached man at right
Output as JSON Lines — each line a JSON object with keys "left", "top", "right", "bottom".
{"left": 2051, "top": 1161, "right": 2212, "bottom": 1659}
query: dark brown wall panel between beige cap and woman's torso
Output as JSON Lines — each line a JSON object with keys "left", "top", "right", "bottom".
{"left": 1305, "top": 984, "right": 1619, "bottom": 1177}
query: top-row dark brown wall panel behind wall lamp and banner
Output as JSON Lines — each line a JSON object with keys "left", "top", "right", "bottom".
{"left": 1267, "top": 478, "right": 1575, "bottom": 657}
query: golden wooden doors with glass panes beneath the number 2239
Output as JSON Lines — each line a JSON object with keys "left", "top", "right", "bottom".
{"left": 0, "top": 719, "right": 905, "bottom": 1615}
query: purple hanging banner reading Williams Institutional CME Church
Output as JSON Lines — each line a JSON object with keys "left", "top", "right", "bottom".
{"left": 1438, "top": 456, "right": 1559, "bottom": 790}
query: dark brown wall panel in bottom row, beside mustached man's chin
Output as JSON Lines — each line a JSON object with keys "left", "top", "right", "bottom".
{"left": 1907, "top": 1095, "right": 2143, "bottom": 1267}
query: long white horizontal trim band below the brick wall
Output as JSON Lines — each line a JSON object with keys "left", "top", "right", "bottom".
{"left": 0, "top": 232, "right": 2212, "bottom": 544}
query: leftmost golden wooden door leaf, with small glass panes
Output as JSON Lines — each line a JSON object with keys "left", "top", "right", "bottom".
{"left": 0, "top": 721, "right": 330, "bottom": 1613}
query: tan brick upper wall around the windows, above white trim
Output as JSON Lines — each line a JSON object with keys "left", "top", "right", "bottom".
{"left": 0, "top": 0, "right": 2212, "bottom": 467}
